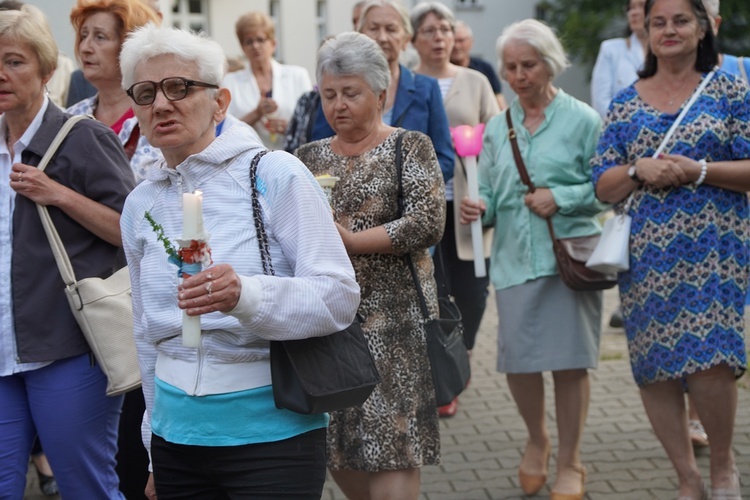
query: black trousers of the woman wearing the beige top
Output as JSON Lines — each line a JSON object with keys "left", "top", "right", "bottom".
{"left": 433, "top": 201, "right": 490, "bottom": 349}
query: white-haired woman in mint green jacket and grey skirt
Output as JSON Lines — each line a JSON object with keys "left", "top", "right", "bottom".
{"left": 461, "top": 19, "right": 604, "bottom": 500}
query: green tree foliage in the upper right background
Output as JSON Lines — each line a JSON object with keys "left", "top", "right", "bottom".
{"left": 538, "top": 0, "right": 750, "bottom": 68}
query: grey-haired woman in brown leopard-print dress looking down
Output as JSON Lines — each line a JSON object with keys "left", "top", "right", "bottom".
{"left": 296, "top": 33, "right": 445, "bottom": 500}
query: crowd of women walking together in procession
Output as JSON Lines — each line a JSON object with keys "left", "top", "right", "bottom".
{"left": 0, "top": 0, "right": 750, "bottom": 500}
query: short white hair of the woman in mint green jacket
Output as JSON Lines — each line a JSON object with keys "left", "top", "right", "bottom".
{"left": 495, "top": 19, "right": 570, "bottom": 80}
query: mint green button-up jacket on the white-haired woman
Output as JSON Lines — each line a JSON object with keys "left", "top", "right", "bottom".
{"left": 478, "top": 90, "right": 607, "bottom": 290}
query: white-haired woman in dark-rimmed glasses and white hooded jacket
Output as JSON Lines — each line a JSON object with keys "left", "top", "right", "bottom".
{"left": 120, "top": 21, "right": 359, "bottom": 499}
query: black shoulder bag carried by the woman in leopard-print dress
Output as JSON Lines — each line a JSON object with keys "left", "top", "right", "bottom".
{"left": 396, "top": 132, "right": 471, "bottom": 406}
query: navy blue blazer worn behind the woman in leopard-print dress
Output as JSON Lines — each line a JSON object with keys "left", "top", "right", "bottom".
{"left": 310, "top": 65, "right": 455, "bottom": 182}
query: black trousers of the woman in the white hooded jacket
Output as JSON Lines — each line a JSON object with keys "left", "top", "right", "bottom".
{"left": 151, "top": 429, "right": 326, "bottom": 500}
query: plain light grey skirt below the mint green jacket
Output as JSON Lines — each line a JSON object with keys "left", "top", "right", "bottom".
{"left": 495, "top": 275, "right": 602, "bottom": 373}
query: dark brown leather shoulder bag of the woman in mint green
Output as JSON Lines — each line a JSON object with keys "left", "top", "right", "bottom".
{"left": 505, "top": 109, "right": 617, "bottom": 291}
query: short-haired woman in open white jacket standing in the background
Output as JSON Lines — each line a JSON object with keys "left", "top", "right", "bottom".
{"left": 222, "top": 12, "right": 312, "bottom": 149}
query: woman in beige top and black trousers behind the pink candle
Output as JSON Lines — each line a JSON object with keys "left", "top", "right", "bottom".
{"left": 411, "top": 2, "right": 500, "bottom": 417}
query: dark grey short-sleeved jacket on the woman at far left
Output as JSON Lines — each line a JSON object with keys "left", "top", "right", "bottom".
{"left": 12, "top": 101, "right": 135, "bottom": 363}
